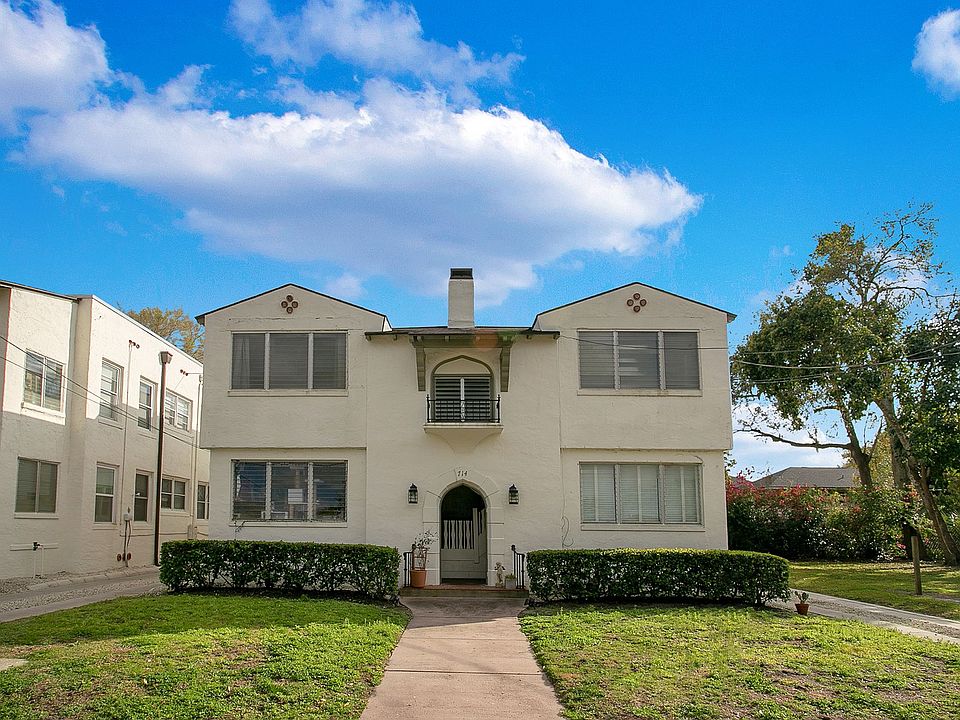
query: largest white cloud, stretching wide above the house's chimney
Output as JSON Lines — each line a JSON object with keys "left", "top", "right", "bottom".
{"left": 25, "top": 80, "right": 700, "bottom": 304}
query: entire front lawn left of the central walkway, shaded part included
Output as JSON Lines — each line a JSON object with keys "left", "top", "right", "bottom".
{"left": 0, "top": 595, "right": 407, "bottom": 720}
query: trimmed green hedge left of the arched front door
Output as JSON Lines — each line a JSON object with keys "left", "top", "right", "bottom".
{"left": 160, "top": 540, "right": 400, "bottom": 599}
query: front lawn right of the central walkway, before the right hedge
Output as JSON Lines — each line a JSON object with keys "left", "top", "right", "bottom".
{"left": 521, "top": 605, "right": 960, "bottom": 720}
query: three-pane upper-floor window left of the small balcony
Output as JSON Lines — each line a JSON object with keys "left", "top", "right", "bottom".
{"left": 230, "top": 332, "right": 347, "bottom": 390}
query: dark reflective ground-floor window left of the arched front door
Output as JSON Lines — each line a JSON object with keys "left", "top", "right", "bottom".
{"left": 232, "top": 460, "right": 347, "bottom": 522}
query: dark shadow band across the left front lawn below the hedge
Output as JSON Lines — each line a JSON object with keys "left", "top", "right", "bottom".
{"left": 0, "top": 593, "right": 407, "bottom": 645}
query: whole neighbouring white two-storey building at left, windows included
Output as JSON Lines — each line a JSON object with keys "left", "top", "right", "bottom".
{"left": 0, "top": 281, "right": 210, "bottom": 577}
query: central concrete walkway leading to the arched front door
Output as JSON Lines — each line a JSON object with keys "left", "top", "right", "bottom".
{"left": 360, "top": 598, "right": 560, "bottom": 720}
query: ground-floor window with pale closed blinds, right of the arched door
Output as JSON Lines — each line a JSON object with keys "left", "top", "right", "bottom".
{"left": 580, "top": 463, "right": 703, "bottom": 525}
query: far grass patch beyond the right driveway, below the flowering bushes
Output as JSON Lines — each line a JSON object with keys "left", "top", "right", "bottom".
{"left": 790, "top": 562, "right": 960, "bottom": 620}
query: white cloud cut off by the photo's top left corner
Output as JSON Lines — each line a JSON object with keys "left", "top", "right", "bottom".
{"left": 0, "top": 0, "right": 111, "bottom": 131}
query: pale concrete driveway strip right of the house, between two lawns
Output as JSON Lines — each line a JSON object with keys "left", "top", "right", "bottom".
{"left": 771, "top": 593, "right": 960, "bottom": 644}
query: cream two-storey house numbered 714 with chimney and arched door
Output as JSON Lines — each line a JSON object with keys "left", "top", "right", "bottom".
{"left": 199, "top": 268, "right": 732, "bottom": 584}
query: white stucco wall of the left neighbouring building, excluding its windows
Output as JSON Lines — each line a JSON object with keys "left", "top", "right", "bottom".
{"left": 0, "top": 288, "right": 209, "bottom": 577}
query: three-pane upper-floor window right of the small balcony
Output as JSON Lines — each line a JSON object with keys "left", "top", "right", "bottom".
{"left": 578, "top": 330, "right": 700, "bottom": 390}
